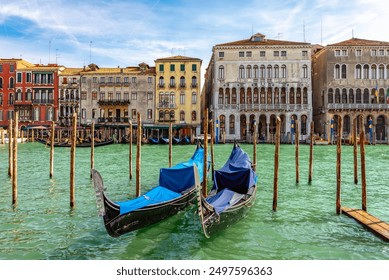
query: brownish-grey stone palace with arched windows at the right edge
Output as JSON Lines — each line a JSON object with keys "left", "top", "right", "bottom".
{"left": 313, "top": 38, "right": 389, "bottom": 143}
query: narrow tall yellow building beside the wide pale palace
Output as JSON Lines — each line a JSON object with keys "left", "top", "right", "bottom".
{"left": 152, "top": 56, "right": 202, "bottom": 139}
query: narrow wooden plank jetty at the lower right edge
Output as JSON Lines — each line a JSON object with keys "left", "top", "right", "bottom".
{"left": 341, "top": 206, "right": 389, "bottom": 242}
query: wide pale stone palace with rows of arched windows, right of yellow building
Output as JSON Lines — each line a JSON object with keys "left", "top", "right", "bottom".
{"left": 204, "top": 33, "right": 312, "bottom": 142}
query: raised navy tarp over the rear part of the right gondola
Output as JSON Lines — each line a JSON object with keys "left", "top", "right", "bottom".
{"left": 213, "top": 145, "right": 256, "bottom": 194}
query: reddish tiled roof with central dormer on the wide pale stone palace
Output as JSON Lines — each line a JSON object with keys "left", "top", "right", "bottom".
{"left": 215, "top": 33, "right": 311, "bottom": 47}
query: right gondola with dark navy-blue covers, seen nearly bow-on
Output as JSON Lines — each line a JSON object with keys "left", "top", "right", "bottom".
{"left": 196, "top": 143, "right": 257, "bottom": 238}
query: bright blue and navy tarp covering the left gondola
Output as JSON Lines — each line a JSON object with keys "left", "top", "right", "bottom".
{"left": 117, "top": 147, "right": 204, "bottom": 214}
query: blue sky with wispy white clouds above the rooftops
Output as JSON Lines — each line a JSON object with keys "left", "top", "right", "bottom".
{"left": 0, "top": 0, "right": 389, "bottom": 68}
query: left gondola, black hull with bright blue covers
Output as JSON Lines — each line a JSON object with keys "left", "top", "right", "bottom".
{"left": 92, "top": 143, "right": 204, "bottom": 237}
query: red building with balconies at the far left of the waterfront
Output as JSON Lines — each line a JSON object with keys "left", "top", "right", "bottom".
{"left": 0, "top": 59, "right": 62, "bottom": 128}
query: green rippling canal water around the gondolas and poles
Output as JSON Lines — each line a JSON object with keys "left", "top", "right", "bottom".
{"left": 0, "top": 143, "right": 389, "bottom": 260}
